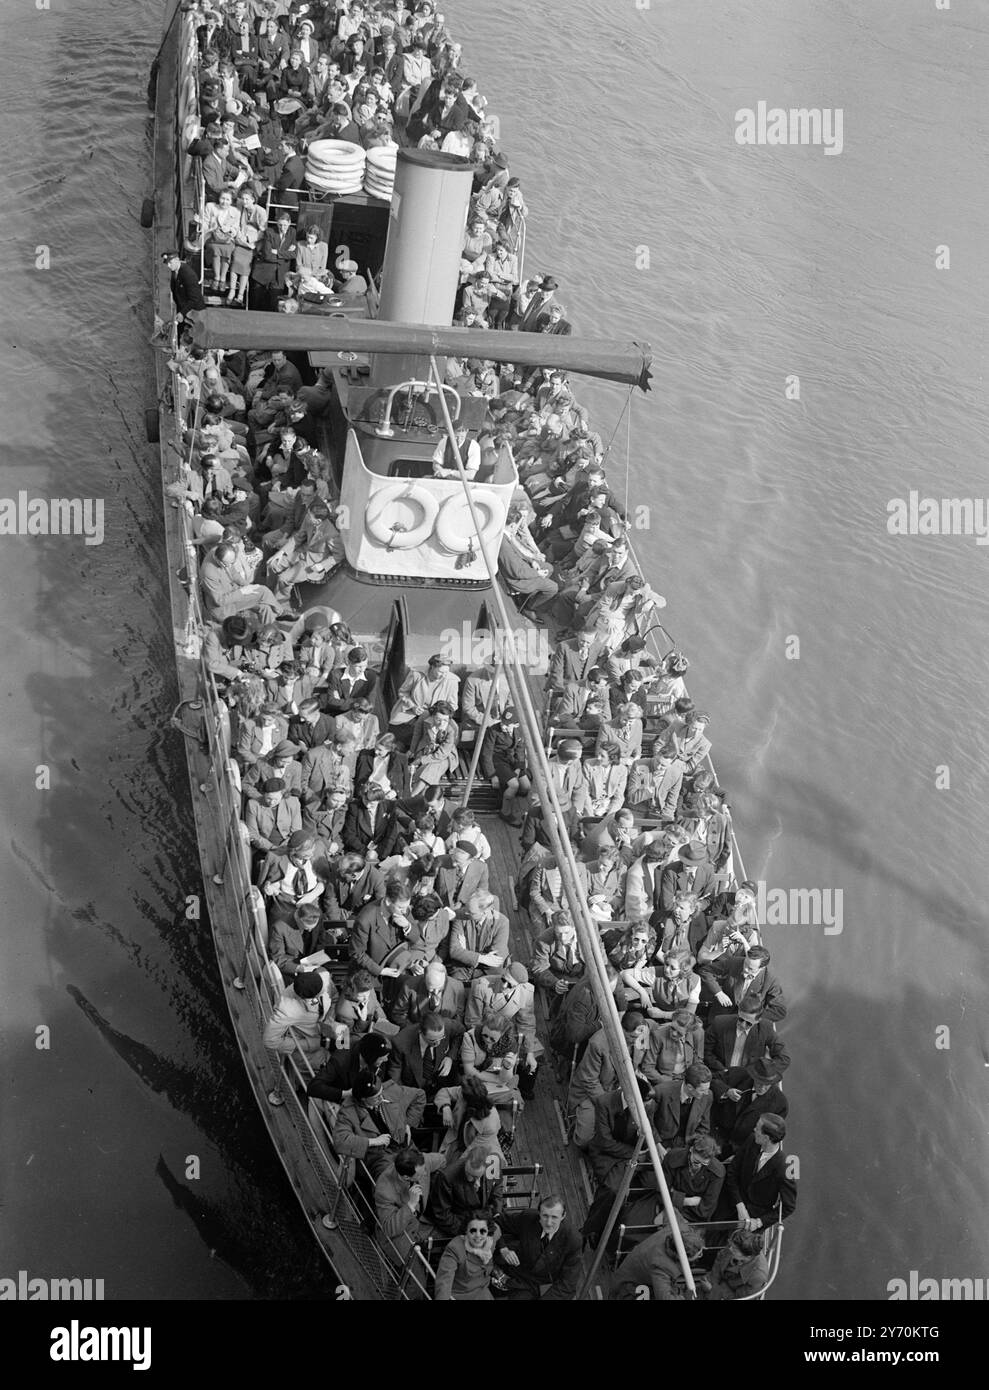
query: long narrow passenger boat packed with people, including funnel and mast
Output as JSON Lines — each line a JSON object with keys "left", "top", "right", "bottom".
{"left": 143, "top": 0, "right": 796, "bottom": 1301}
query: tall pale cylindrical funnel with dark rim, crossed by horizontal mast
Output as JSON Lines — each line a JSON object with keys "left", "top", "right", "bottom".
{"left": 371, "top": 150, "right": 474, "bottom": 386}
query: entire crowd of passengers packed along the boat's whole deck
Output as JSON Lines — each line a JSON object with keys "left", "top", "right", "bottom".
{"left": 160, "top": 0, "right": 796, "bottom": 1300}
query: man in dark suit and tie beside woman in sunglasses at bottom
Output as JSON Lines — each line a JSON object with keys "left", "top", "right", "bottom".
{"left": 495, "top": 1194, "right": 581, "bottom": 1302}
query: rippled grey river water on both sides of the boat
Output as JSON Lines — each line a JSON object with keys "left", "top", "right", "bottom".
{"left": 0, "top": 0, "right": 989, "bottom": 1300}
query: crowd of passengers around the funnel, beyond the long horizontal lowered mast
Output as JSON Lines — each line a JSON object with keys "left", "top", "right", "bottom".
{"left": 165, "top": 0, "right": 561, "bottom": 322}
